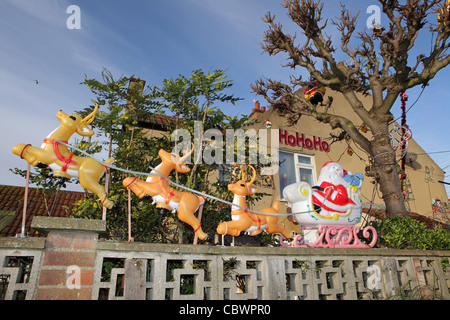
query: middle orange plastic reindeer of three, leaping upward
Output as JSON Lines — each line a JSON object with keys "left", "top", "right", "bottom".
{"left": 123, "top": 144, "right": 208, "bottom": 240}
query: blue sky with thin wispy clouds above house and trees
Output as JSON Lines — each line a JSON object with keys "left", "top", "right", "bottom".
{"left": 0, "top": 0, "right": 450, "bottom": 192}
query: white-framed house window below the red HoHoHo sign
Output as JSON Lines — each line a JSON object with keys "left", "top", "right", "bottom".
{"left": 279, "top": 151, "right": 316, "bottom": 193}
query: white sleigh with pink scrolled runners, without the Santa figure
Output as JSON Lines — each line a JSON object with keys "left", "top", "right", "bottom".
{"left": 280, "top": 182, "right": 377, "bottom": 248}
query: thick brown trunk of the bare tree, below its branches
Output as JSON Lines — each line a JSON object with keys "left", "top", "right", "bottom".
{"left": 372, "top": 130, "right": 408, "bottom": 218}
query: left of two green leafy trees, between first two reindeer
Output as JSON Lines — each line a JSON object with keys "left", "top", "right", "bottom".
{"left": 70, "top": 69, "right": 159, "bottom": 241}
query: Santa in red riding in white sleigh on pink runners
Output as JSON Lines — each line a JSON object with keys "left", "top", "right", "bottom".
{"left": 280, "top": 161, "right": 377, "bottom": 248}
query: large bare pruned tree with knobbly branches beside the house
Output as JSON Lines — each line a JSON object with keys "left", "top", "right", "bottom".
{"left": 252, "top": 0, "right": 450, "bottom": 216}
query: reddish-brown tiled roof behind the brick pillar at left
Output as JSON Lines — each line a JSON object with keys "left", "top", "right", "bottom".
{"left": 0, "top": 185, "right": 85, "bottom": 237}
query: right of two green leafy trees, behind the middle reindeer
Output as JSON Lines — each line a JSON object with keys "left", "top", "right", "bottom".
{"left": 151, "top": 70, "right": 253, "bottom": 242}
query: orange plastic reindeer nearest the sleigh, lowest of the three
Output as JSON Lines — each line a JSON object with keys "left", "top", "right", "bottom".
{"left": 217, "top": 166, "right": 294, "bottom": 239}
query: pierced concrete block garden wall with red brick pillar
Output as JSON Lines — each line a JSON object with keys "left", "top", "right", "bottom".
{"left": 0, "top": 217, "right": 450, "bottom": 300}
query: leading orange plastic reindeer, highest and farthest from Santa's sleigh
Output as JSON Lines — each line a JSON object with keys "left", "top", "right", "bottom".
{"left": 12, "top": 101, "right": 114, "bottom": 209}
